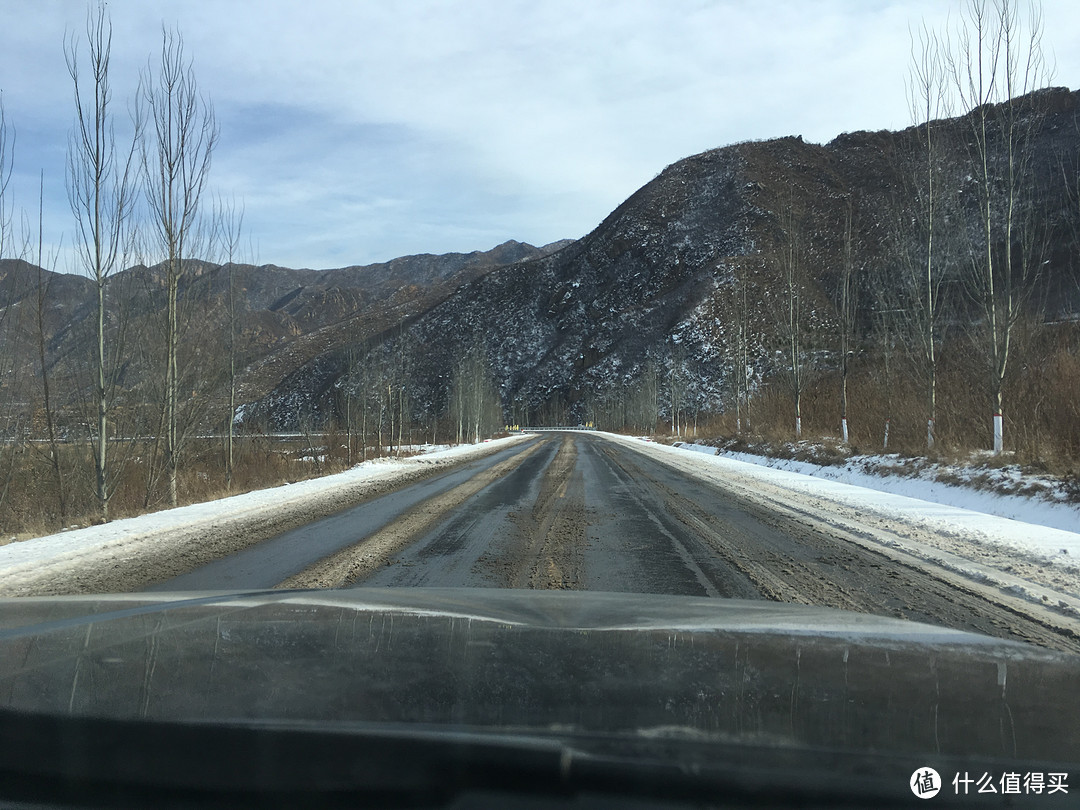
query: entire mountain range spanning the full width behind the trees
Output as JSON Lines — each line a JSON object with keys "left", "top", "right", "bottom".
{"left": 0, "top": 89, "right": 1080, "bottom": 444}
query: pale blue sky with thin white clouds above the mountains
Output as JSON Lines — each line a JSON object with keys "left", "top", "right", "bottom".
{"left": 0, "top": 0, "right": 1080, "bottom": 272}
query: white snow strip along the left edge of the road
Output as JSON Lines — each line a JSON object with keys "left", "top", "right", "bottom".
{"left": 0, "top": 436, "right": 521, "bottom": 576}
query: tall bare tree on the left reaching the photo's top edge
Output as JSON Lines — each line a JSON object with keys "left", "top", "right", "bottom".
{"left": 64, "top": 3, "right": 139, "bottom": 521}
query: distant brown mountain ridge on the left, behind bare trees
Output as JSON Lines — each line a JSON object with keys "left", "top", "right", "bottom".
{"left": 0, "top": 241, "right": 566, "bottom": 412}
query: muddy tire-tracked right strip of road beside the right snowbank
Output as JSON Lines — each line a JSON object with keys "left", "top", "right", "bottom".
{"left": 604, "top": 434, "right": 1080, "bottom": 652}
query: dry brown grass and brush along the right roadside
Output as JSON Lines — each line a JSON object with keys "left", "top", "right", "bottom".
{"left": 665, "top": 324, "right": 1080, "bottom": 489}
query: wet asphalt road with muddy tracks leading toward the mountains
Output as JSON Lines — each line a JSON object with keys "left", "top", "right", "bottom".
{"left": 156, "top": 433, "right": 1080, "bottom": 651}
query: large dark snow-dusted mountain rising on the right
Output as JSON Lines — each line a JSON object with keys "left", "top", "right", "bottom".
{"left": 247, "top": 89, "right": 1080, "bottom": 434}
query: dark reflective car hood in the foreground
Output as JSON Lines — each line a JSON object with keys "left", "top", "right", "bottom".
{"left": 0, "top": 589, "right": 1080, "bottom": 761}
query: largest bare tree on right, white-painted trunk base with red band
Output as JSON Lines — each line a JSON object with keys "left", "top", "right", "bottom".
{"left": 947, "top": 0, "right": 1050, "bottom": 453}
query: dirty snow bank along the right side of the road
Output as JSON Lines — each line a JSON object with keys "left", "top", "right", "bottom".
{"left": 591, "top": 434, "right": 1080, "bottom": 633}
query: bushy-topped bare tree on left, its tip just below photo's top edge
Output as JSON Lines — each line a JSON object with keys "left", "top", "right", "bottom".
{"left": 140, "top": 29, "right": 218, "bottom": 505}
